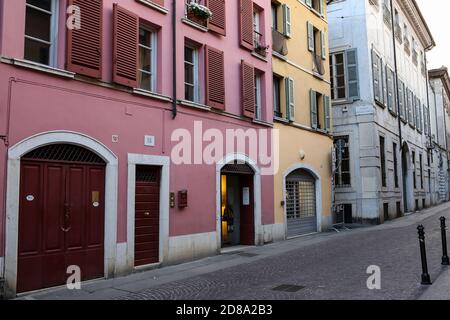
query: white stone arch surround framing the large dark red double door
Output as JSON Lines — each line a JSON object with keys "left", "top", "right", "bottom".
{"left": 4, "top": 130, "right": 118, "bottom": 298}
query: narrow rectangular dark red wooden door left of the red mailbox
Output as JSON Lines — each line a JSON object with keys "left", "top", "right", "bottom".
{"left": 134, "top": 166, "right": 161, "bottom": 266}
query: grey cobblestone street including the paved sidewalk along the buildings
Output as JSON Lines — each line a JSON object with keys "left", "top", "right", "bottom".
{"left": 27, "top": 205, "right": 450, "bottom": 300}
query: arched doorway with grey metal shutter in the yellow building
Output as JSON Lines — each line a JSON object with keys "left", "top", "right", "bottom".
{"left": 285, "top": 169, "right": 318, "bottom": 238}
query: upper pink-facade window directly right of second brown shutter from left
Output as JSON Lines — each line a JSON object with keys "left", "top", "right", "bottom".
{"left": 138, "top": 26, "right": 156, "bottom": 92}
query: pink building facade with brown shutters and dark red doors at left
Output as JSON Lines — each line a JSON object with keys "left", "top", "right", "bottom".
{"left": 0, "top": 0, "right": 284, "bottom": 296}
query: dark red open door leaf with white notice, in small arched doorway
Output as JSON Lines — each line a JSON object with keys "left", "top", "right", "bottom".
{"left": 239, "top": 175, "right": 255, "bottom": 246}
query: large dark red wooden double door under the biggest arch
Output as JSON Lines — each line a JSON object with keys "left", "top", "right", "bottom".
{"left": 17, "top": 160, "right": 105, "bottom": 292}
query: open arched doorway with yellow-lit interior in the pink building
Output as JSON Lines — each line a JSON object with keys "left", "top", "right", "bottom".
{"left": 221, "top": 161, "right": 255, "bottom": 248}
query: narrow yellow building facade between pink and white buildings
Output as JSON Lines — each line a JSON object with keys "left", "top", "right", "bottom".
{"left": 272, "top": 0, "right": 333, "bottom": 238}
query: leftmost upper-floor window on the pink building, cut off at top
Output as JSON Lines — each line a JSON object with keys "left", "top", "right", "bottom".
{"left": 24, "top": 0, "right": 59, "bottom": 67}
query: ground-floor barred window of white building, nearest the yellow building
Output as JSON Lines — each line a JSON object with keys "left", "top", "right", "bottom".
{"left": 334, "top": 136, "right": 351, "bottom": 188}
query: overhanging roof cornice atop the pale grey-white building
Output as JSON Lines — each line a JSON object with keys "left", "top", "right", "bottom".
{"left": 397, "top": 0, "right": 436, "bottom": 51}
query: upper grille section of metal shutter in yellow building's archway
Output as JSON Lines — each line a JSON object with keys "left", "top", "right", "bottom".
{"left": 286, "top": 179, "right": 316, "bottom": 220}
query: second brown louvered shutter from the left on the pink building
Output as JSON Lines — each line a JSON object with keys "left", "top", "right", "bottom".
{"left": 113, "top": 4, "right": 139, "bottom": 88}
